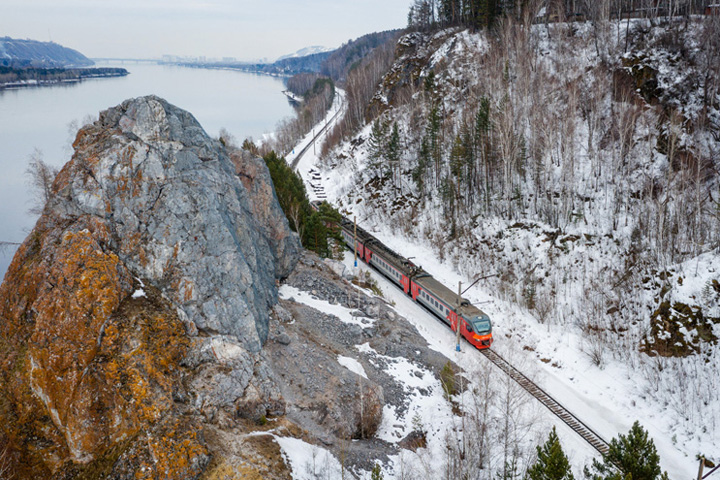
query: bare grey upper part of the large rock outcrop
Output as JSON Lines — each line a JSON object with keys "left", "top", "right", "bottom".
{"left": 50, "top": 96, "right": 300, "bottom": 352}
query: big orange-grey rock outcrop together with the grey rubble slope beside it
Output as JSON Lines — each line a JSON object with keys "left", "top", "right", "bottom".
{"left": 0, "top": 97, "right": 458, "bottom": 480}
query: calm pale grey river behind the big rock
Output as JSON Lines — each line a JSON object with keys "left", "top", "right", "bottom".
{"left": 0, "top": 64, "right": 293, "bottom": 279}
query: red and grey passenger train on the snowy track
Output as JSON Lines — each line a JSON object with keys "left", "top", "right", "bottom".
{"left": 340, "top": 210, "right": 493, "bottom": 349}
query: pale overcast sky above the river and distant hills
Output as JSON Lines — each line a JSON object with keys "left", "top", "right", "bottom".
{"left": 0, "top": 0, "right": 411, "bottom": 60}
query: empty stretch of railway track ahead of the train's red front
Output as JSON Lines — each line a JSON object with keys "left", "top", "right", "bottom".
{"left": 480, "top": 348, "right": 609, "bottom": 455}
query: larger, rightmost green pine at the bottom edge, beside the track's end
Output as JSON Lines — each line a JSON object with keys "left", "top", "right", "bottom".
{"left": 585, "top": 421, "right": 668, "bottom": 480}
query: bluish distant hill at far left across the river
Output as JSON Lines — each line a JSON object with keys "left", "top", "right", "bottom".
{"left": 0, "top": 37, "right": 94, "bottom": 68}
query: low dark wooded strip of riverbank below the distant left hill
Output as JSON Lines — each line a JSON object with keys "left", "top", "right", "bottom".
{"left": 0, "top": 67, "right": 130, "bottom": 90}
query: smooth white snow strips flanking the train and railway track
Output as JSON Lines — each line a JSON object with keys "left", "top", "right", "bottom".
{"left": 280, "top": 142, "right": 718, "bottom": 479}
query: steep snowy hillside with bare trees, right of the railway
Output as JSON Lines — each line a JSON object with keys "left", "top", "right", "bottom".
{"left": 268, "top": 0, "right": 720, "bottom": 476}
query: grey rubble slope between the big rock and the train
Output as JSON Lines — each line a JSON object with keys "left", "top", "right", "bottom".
{"left": 264, "top": 254, "right": 459, "bottom": 472}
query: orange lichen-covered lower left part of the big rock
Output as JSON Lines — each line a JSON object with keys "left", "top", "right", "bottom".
{"left": 0, "top": 217, "right": 200, "bottom": 478}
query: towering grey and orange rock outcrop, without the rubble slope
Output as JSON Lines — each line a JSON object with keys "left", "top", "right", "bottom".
{"left": 0, "top": 97, "right": 300, "bottom": 478}
